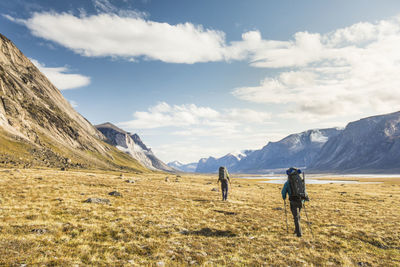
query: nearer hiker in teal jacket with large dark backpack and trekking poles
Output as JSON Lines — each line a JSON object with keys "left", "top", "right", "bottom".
{"left": 282, "top": 167, "right": 309, "bottom": 237}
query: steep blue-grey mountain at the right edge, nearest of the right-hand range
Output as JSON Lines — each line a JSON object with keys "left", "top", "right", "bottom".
{"left": 310, "top": 112, "right": 400, "bottom": 173}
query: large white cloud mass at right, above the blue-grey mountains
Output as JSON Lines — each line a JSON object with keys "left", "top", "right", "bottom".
{"left": 232, "top": 17, "right": 400, "bottom": 121}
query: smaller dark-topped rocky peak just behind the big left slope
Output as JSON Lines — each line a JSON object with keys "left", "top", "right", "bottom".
{"left": 96, "top": 122, "right": 174, "bottom": 172}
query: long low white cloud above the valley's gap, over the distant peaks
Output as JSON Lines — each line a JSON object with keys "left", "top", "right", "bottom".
{"left": 119, "top": 102, "right": 271, "bottom": 131}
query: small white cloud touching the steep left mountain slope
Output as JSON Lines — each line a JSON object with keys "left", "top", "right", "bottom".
{"left": 31, "top": 59, "right": 90, "bottom": 90}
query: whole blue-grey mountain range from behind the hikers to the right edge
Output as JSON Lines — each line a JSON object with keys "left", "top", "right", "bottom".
{"left": 189, "top": 112, "right": 400, "bottom": 173}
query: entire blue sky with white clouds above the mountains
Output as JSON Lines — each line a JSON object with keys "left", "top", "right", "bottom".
{"left": 0, "top": 0, "right": 400, "bottom": 163}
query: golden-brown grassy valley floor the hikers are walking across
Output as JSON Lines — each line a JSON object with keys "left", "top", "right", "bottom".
{"left": 0, "top": 169, "right": 400, "bottom": 266}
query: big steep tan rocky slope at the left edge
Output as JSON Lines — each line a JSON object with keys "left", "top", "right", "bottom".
{"left": 0, "top": 34, "right": 145, "bottom": 170}
